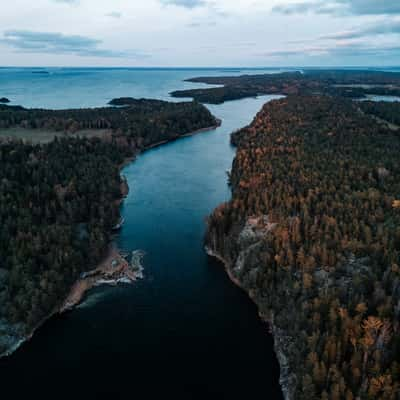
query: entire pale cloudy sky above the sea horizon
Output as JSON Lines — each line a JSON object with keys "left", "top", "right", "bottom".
{"left": 0, "top": 0, "right": 400, "bottom": 67}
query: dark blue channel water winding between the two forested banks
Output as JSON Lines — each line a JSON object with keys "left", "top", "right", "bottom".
{"left": 0, "top": 96, "right": 281, "bottom": 400}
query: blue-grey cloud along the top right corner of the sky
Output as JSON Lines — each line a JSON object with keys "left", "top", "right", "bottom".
{"left": 273, "top": 0, "right": 400, "bottom": 15}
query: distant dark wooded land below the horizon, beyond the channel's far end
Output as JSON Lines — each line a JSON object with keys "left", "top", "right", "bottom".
{"left": 171, "top": 70, "right": 400, "bottom": 104}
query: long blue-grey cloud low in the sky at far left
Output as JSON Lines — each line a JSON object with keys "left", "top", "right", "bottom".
{"left": 0, "top": 30, "right": 145, "bottom": 57}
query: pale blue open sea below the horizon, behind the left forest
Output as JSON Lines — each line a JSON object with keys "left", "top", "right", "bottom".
{"left": 0, "top": 68, "right": 283, "bottom": 109}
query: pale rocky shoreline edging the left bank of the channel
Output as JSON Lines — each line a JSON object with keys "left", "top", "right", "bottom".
{"left": 0, "top": 118, "right": 222, "bottom": 360}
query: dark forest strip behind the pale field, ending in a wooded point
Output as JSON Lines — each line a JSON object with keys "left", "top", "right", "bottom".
{"left": 0, "top": 99, "right": 216, "bottom": 147}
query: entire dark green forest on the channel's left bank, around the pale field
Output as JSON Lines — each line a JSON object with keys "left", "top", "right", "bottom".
{"left": 0, "top": 100, "right": 216, "bottom": 354}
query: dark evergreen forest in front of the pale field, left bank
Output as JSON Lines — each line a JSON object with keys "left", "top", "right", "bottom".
{"left": 0, "top": 139, "right": 129, "bottom": 328}
